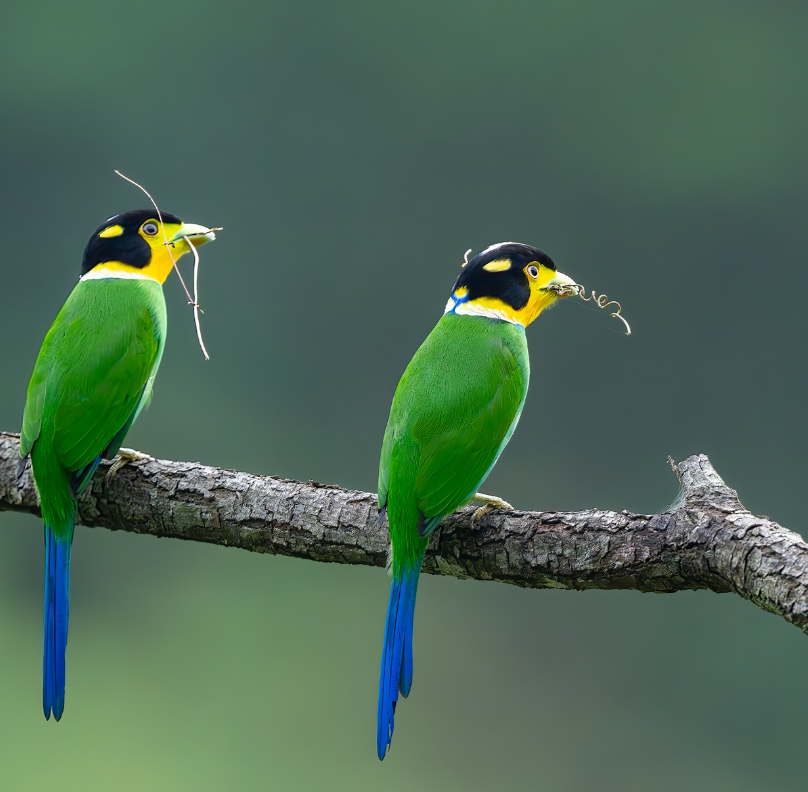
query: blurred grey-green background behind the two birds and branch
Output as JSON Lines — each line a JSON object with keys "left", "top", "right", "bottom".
{"left": 0, "top": 0, "right": 808, "bottom": 792}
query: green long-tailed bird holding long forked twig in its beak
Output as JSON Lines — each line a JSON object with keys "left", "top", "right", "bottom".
{"left": 20, "top": 209, "right": 215, "bottom": 721}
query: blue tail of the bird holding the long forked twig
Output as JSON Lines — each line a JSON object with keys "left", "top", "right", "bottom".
{"left": 42, "top": 527, "right": 72, "bottom": 720}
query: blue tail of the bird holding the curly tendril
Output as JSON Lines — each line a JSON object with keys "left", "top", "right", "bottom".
{"left": 376, "top": 561, "right": 421, "bottom": 759}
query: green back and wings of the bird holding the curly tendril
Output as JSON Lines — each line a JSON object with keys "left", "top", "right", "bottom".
{"left": 379, "top": 313, "right": 530, "bottom": 571}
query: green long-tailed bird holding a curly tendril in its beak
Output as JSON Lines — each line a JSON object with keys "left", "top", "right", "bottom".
{"left": 376, "top": 242, "right": 577, "bottom": 759}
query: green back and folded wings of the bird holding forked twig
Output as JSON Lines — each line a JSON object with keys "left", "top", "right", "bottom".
{"left": 20, "top": 279, "right": 165, "bottom": 471}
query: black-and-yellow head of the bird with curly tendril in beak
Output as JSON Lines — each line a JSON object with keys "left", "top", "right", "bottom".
{"left": 446, "top": 242, "right": 575, "bottom": 327}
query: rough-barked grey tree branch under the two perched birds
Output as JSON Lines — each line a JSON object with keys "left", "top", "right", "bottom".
{"left": 0, "top": 433, "right": 808, "bottom": 632}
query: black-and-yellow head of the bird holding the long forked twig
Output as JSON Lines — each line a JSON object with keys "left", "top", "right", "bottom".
{"left": 81, "top": 209, "right": 216, "bottom": 283}
